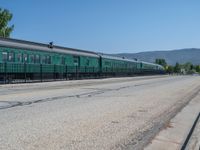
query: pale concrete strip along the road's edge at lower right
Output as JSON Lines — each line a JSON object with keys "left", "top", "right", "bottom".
{"left": 145, "top": 93, "right": 200, "bottom": 150}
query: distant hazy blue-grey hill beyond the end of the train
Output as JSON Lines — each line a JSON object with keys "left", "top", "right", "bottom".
{"left": 112, "top": 48, "right": 200, "bottom": 65}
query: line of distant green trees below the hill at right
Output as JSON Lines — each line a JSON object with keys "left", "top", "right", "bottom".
{"left": 155, "top": 59, "right": 200, "bottom": 74}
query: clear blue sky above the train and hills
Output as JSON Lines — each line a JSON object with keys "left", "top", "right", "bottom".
{"left": 0, "top": 0, "right": 200, "bottom": 53}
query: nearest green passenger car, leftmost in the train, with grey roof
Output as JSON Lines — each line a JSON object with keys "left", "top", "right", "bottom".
{"left": 0, "top": 38, "right": 99, "bottom": 82}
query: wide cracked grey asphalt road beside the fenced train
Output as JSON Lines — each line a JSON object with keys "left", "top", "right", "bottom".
{"left": 0, "top": 76, "right": 200, "bottom": 150}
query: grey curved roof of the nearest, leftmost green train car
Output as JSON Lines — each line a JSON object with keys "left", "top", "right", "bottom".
{"left": 0, "top": 37, "right": 99, "bottom": 57}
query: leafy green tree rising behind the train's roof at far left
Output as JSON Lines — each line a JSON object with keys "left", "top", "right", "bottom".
{"left": 0, "top": 8, "right": 14, "bottom": 37}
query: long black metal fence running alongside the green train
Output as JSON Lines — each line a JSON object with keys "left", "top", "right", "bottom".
{"left": 0, "top": 62, "right": 162, "bottom": 83}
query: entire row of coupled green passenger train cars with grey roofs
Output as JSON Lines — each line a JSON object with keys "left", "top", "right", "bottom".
{"left": 0, "top": 38, "right": 163, "bottom": 83}
